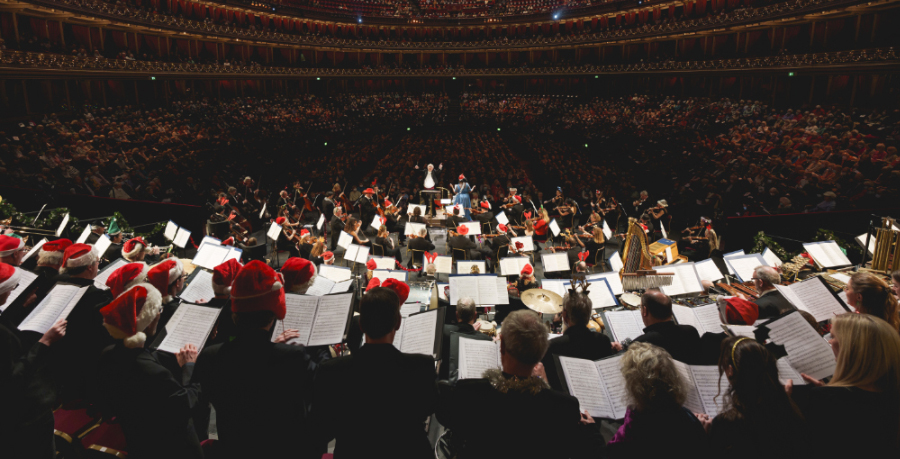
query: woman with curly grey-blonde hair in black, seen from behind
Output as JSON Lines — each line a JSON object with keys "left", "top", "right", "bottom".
{"left": 608, "top": 342, "right": 708, "bottom": 458}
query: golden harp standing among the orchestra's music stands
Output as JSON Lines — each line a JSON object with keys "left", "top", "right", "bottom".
{"left": 620, "top": 218, "right": 674, "bottom": 290}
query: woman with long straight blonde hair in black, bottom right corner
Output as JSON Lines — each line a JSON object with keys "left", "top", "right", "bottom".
{"left": 787, "top": 313, "right": 900, "bottom": 457}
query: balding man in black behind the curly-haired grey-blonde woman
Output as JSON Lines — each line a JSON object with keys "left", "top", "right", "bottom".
{"left": 613, "top": 290, "right": 700, "bottom": 364}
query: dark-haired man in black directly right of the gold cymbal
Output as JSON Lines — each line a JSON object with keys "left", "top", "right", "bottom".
{"left": 543, "top": 287, "right": 614, "bottom": 390}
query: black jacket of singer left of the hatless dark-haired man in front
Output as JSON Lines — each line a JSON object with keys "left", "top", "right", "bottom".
{"left": 191, "top": 330, "right": 316, "bottom": 458}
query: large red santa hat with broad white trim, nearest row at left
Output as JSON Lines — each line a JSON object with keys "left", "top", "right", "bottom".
{"left": 100, "top": 284, "right": 162, "bottom": 349}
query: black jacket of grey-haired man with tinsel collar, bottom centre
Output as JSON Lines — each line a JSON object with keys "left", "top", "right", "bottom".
{"left": 437, "top": 370, "right": 603, "bottom": 459}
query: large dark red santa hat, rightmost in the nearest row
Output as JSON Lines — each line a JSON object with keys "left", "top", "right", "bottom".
{"left": 231, "top": 260, "right": 287, "bottom": 320}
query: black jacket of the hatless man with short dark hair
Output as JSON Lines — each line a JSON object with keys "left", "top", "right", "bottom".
{"left": 312, "top": 344, "right": 437, "bottom": 459}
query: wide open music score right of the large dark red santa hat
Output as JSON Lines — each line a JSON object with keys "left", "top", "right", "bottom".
{"left": 272, "top": 293, "right": 353, "bottom": 346}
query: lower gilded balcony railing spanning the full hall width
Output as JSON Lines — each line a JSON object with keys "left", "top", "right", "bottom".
{"left": 0, "top": 47, "right": 900, "bottom": 79}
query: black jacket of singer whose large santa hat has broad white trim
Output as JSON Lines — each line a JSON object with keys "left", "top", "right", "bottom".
{"left": 98, "top": 339, "right": 203, "bottom": 459}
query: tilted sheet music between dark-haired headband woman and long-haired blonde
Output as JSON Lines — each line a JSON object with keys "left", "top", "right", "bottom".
{"left": 766, "top": 312, "right": 835, "bottom": 379}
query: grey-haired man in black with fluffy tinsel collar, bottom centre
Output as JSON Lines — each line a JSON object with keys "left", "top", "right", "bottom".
{"left": 438, "top": 310, "right": 603, "bottom": 458}
